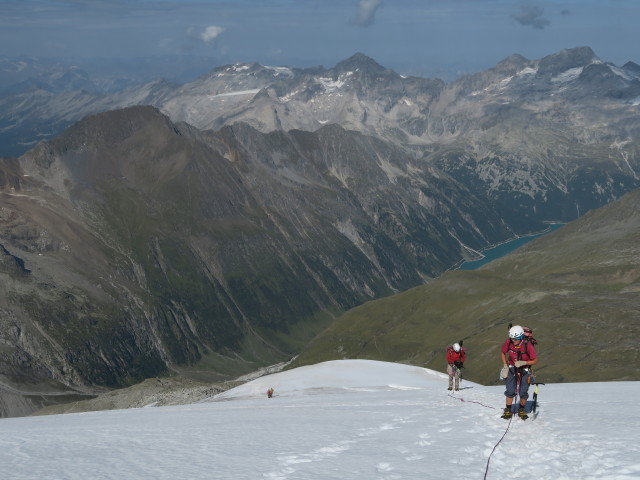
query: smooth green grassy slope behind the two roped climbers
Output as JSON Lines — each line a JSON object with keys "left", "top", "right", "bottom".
{"left": 292, "top": 191, "right": 640, "bottom": 384}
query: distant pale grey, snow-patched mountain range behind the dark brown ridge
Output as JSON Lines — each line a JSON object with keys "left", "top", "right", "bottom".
{"left": 0, "top": 47, "right": 640, "bottom": 230}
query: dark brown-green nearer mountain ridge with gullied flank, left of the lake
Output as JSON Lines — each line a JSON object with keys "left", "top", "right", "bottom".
{"left": 0, "top": 107, "right": 512, "bottom": 413}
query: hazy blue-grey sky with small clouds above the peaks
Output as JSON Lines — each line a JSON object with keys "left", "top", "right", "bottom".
{"left": 0, "top": 0, "right": 640, "bottom": 77}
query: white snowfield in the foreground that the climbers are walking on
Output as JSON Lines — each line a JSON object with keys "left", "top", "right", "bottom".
{"left": 0, "top": 359, "right": 640, "bottom": 480}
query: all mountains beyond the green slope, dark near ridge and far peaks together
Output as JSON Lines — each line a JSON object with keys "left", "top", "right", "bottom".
{"left": 0, "top": 48, "right": 640, "bottom": 414}
